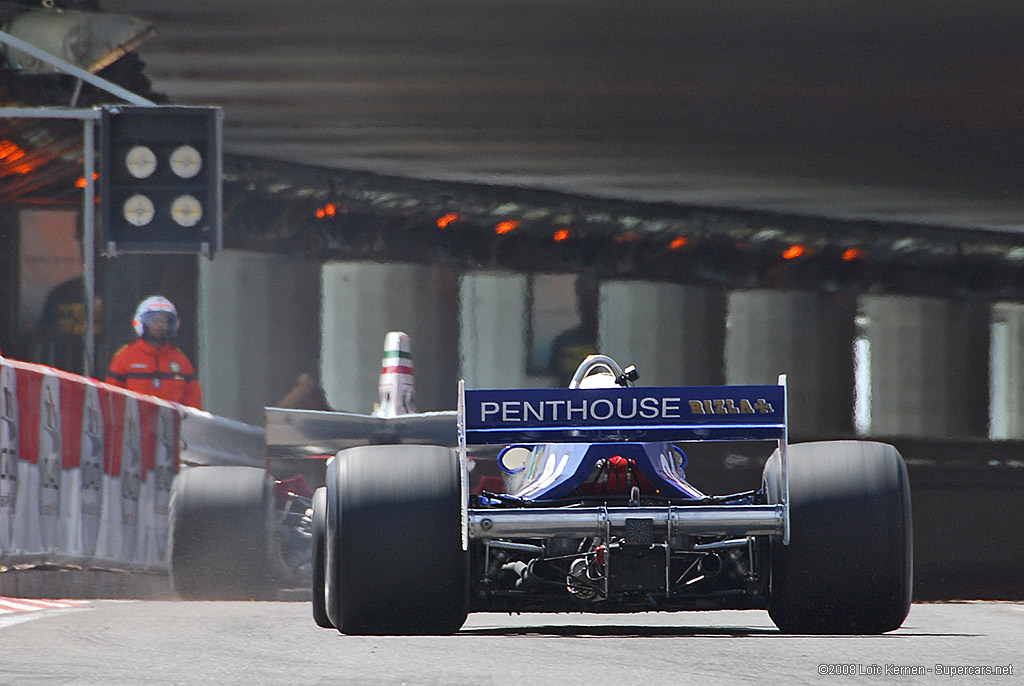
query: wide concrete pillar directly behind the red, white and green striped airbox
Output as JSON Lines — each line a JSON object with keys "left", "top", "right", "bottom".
{"left": 321, "top": 262, "right": 459, "bottom": 413}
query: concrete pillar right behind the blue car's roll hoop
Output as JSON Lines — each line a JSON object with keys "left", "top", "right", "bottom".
{"left": 598, "top": 281, "right": 725, "bottom": 386}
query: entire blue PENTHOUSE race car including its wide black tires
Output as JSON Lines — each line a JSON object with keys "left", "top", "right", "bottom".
{"left": 312, "top": 355, "right": 912, "bottom": 634}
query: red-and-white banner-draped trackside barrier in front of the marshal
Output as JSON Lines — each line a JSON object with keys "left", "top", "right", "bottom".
{"left": 0, "top": 357, "right": 264, "bottom": 572}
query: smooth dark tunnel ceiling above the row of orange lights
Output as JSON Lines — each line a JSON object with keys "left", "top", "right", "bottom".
{"left": 102, "top": 0, "right": 1024, "bottom": 231}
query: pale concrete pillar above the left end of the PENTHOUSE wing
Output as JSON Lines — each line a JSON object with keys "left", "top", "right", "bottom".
{"left": 459, "top": 271, "right": 536, "bottom": 388}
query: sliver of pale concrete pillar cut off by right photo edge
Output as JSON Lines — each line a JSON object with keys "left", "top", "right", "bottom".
{"left": 989, "top": 303, "right": 1024, "bottom": 438}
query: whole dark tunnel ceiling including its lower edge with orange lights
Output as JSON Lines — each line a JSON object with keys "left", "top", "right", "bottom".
{"left": 6, "top": 0, "right": 1024, "bottom": 300}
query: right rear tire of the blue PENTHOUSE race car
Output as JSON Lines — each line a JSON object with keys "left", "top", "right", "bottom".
{"left": 764, "top": 440, "right": 913, "bottom": 634}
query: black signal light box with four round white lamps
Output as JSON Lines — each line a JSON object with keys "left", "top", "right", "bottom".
{"left": 98, "top": 105, "right": 223, "bottom": 255}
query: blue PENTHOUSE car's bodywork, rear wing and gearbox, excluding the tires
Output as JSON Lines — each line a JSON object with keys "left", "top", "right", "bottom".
{"left": 459, "top": 358, "right": 787, "bottom": 612}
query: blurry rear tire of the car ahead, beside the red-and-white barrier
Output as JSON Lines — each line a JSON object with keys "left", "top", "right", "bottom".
{"left": 168, "top": 467, "right": 278, "bottom": 600}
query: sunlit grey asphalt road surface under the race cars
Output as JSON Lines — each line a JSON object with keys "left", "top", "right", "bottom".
{"left": 0, "top": 600, "right": 1024, "bottom": 686}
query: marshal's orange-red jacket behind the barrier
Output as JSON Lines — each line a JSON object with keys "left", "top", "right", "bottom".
{"left": 106, "top": 338, "right": 203, "bottom": 410}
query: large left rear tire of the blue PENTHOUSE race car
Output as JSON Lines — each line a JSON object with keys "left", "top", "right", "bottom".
{"left": 327, "top": 445, "right": 469, "bottom": 634}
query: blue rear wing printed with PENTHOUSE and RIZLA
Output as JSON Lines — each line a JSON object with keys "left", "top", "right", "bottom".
{"left": 457, "top": 375, "right": 790, "bottom": 545}
